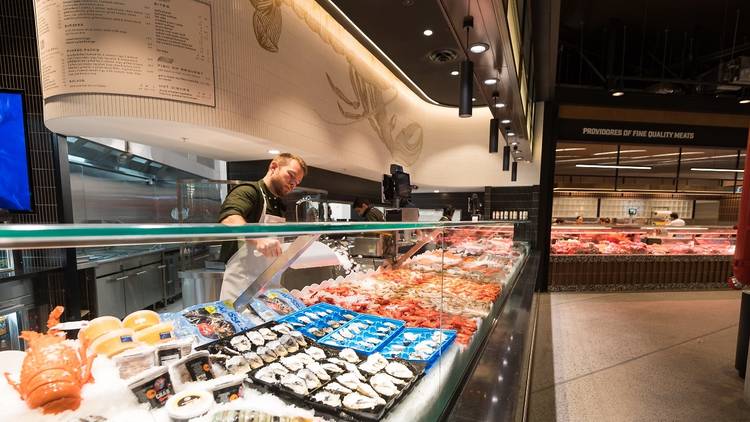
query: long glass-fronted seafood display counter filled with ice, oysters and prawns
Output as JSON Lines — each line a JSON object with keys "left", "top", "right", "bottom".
{"left": 0, "top": 222, "right": 529, "bottom": 422}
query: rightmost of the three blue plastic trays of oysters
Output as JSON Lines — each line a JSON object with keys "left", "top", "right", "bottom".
{"left": 380, "top": 328, "right": 456, "bottom": 370}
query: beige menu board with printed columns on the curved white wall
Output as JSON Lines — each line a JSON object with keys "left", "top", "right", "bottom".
{"left": 35, "top": 0, "right": 216, "bottom": 106}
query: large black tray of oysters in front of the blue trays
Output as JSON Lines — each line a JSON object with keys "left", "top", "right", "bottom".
{"left": 250, "top": 345, "right": 424, "bottom": 421}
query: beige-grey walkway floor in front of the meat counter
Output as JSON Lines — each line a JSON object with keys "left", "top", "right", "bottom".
{"left": 529, "top": 291, "right": 750, "bottom": 422}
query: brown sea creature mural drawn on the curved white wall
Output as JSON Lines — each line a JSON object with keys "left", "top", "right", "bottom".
{"left": 250, "top": 0, "right": 423, "bottom": 165}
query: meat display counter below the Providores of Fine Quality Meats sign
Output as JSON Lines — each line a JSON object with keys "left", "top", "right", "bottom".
{"left": 549, "top": 225, "right": 736, "bottom": 291}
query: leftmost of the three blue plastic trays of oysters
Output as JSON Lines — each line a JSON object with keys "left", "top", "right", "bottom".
{"left": 279, "top": 303, "right": 360, "bottom": 340}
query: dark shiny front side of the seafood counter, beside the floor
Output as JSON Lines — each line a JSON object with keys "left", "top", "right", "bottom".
{"left": 443, "top": 252, "right": 539, "bottom": 422}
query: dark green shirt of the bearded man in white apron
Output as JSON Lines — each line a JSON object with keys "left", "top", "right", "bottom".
{"left": 219, "top": 179, "right": 286, "bottom": 262}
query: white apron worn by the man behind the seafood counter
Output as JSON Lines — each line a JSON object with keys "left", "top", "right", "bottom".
{"left": 219, "top": 189, "right": 286, "bottom": 301}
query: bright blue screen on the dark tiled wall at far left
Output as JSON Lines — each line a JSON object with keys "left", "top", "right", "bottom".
{"left": 0, "top": 91, "right": 32, "bottom": 211}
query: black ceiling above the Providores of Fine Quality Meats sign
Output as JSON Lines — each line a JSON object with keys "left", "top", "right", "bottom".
{"left": 558, "top": 0, "right": 750, "bottom": 97}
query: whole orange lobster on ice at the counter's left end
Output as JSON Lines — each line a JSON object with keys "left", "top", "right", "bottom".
{"left": 5, "top": 306, "right": 93, "bottom": 414}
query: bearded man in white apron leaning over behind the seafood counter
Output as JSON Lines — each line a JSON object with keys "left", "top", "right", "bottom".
{"left": 219, "top": 153, "right": 307, "bottom": 300}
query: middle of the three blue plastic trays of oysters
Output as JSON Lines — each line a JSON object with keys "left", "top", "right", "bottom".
{"left": 318, "top": 314, "right": 406, "bottom": 355}
